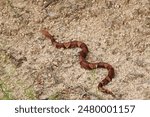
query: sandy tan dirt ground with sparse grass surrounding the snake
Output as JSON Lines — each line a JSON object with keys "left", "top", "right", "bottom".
{"left": 0, "top": 0, "right": 150, "bottom": 100}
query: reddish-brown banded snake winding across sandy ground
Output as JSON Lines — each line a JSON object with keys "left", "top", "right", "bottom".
{"left": 41, "top": 30, "right": 115, "bottom": 97}
